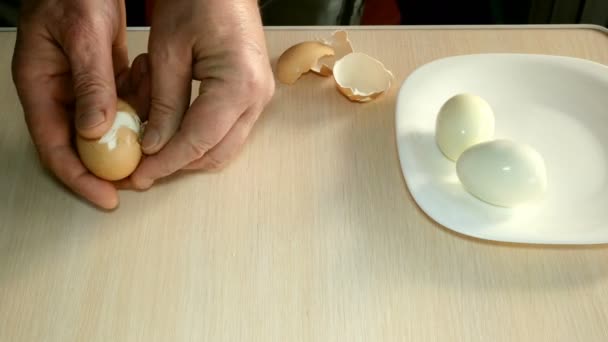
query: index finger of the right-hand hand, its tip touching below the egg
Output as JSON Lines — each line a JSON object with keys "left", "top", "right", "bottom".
{"left": 131, "top": 81, "right": 247, "bottom": 189}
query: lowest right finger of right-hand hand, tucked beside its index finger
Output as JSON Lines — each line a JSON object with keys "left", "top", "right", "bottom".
{"left": 184, "top": 108, "right": 260, "bottom": 171}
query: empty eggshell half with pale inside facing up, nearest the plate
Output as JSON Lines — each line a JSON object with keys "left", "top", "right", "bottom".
{"left": 333, "top": 52, "right": 394, "bottom": 102}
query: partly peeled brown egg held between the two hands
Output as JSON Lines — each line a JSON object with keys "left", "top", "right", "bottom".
{"left": 76, "top": 100, "right": 142, "bottom": 181}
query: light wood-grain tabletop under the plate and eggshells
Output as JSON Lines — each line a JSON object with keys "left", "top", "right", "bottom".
{"left": 0, "top": 27, "right": 608, "bottom": 342}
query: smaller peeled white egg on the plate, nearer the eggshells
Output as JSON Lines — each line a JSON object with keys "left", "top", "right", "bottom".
{"left": 435, "top": 94, "right": 495, "bottom": 161}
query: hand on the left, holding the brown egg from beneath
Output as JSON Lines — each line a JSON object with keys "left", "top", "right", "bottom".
{"left": 12, "top": 0, "right": 147, "bottom": 209}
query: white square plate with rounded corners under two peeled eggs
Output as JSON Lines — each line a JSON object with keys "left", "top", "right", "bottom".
{"left": 396, "top": 54, "right": 608, "bottom": 244}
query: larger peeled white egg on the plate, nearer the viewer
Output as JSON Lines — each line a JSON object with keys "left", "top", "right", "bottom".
{"left": 456, "top": 139, "right": 547, "bottom": 207}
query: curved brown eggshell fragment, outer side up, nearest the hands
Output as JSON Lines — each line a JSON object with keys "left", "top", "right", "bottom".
{"left": 277, "top": 41, "right": 334, "bottom": 84}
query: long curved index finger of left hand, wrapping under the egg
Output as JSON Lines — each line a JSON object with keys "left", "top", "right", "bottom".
{"left": 12, "top": 25, "right": 118, "bottom": 209}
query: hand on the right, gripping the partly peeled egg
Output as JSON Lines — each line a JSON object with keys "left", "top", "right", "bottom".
{"left": 130, "top": 0, "right": 275, "bottom": 189}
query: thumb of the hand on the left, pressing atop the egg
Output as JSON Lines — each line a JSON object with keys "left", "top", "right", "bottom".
{"left": 64, "top": 29, "right": 116, "bottom": 139}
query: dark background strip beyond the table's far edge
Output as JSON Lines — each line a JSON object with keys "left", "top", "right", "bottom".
{"left": 0, "top": 0, "right": 608, "bottom": 27}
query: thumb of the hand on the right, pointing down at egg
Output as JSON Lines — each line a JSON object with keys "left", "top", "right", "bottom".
{"left": 142, "top": 37, "right": 192, "bottom": 154}
